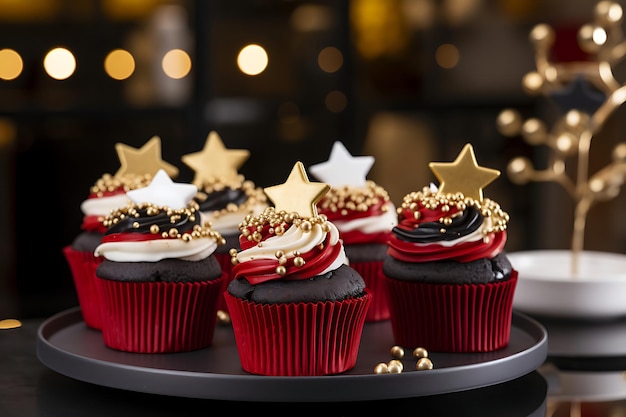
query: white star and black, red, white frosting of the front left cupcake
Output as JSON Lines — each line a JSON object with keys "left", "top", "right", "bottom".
{"left": 95, "top": 169, "right": 224, "bottom": 262}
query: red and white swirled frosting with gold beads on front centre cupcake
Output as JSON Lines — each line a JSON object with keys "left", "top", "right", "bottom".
{"left": 231, "top": 207, "right": 347, "bottom": 285}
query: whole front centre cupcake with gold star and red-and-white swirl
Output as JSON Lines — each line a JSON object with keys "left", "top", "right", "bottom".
{"left": 224, "top": 162, "right": 372, "bottom": 376}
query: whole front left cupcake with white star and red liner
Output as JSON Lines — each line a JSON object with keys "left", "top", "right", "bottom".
{"left": 95, "top": 170, "right": 225, "bottom": 353}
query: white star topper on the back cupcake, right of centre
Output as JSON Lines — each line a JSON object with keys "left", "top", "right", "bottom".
{"left": 309, "top": 141, "right": 374, "bottom": 187}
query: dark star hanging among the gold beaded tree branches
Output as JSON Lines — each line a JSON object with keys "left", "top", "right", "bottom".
{"left": 549, "top": 75, "right": 606, "bottom": 115}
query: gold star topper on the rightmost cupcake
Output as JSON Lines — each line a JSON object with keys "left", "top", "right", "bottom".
{"left": 428, "top": 143, "right": 500, "bottom": 201}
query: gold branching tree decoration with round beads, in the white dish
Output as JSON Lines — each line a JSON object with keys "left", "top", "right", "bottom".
{"left": 497, "top": 1, "right": 626, "bottom": 275}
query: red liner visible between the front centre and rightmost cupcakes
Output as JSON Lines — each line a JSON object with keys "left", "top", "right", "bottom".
{"left": 350, "top": 261, "right": 390, "bottom": 323}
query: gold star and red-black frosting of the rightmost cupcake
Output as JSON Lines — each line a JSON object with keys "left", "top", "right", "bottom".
{"left": 388, "top": 144, "right": 509, "bottom": 263}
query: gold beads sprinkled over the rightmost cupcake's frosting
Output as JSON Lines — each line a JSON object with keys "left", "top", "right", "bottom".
{"left": 397, "top": 187, "right": 509, "bottom": 235}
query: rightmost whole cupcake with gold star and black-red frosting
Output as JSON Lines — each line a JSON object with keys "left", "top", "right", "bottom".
{"left": 383, "top": 144, "right": 517, "bottom": 352}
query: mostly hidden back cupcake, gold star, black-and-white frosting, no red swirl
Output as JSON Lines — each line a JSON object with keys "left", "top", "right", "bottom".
{"left": 182, "top": 131, "right": 267, "bottom": 312}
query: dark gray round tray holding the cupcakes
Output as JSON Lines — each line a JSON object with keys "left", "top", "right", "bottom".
{"left": 37, "top": 308, "right": 548, "bottom": 402}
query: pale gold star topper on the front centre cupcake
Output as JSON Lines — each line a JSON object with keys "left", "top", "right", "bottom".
{"left": 263, "top": 161, "right": 330, "bottom": 217}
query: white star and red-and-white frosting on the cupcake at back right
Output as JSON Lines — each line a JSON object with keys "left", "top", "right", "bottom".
{"left": 309, "top": 141, "right": 398, "bottom": 245}
